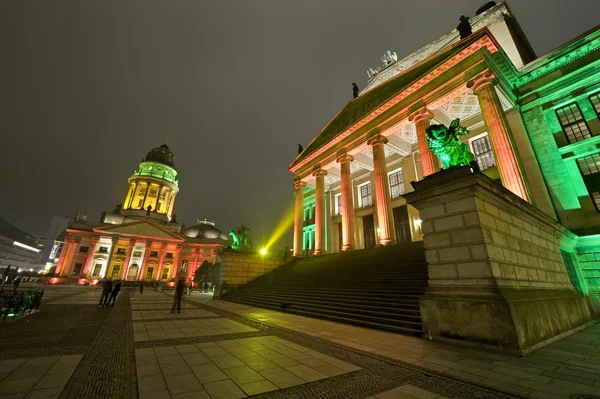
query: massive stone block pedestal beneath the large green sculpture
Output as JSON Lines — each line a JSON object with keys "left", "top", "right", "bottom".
{"left": 405, "top": 167, "right": 593, "bottom": 354}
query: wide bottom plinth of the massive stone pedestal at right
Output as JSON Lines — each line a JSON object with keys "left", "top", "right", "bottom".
{"left": 419, "top": 287, "right": 594, "bottom": 356}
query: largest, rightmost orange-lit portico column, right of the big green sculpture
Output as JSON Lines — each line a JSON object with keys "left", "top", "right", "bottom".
{"left": 467, "top": 69, "right": 531, "bottom": 202}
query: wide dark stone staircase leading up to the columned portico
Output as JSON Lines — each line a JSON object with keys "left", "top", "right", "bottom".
{"left": 222, "top": 242, "right": 427, "bottom": 335}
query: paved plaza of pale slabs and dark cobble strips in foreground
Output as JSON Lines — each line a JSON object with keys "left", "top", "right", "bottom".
{"left": 0, "top": 287, "right": 600, "bottom": 399}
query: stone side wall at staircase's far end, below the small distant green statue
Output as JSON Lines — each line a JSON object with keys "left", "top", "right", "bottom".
{"left": 215, "top": 249, "right": 292, "bottom": 298}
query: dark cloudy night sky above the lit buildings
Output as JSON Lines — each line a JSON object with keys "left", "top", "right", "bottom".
{"left": 0, "top": 0, "right": 600, "bottom": 247}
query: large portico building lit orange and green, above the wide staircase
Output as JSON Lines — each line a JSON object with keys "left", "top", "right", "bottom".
{"left": 289, "top": 2, "right": 600, "bottom": 294}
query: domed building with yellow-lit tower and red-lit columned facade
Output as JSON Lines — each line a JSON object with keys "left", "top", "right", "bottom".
{"left": 51, "top": 144, "right": 230, "bottom": 281}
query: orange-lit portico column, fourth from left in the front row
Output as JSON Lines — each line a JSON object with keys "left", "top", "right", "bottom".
{"left": 367, "top": 134, "right": 395, "bottom": 246}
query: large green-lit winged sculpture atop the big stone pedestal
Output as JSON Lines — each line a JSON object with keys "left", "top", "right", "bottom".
{"left": 426, "top": 118, "right": 475, "bottom": 169}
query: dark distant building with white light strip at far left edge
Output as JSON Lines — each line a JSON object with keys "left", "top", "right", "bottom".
{"left": 0, "top": 218, "right": 42, "bottom": 271}
